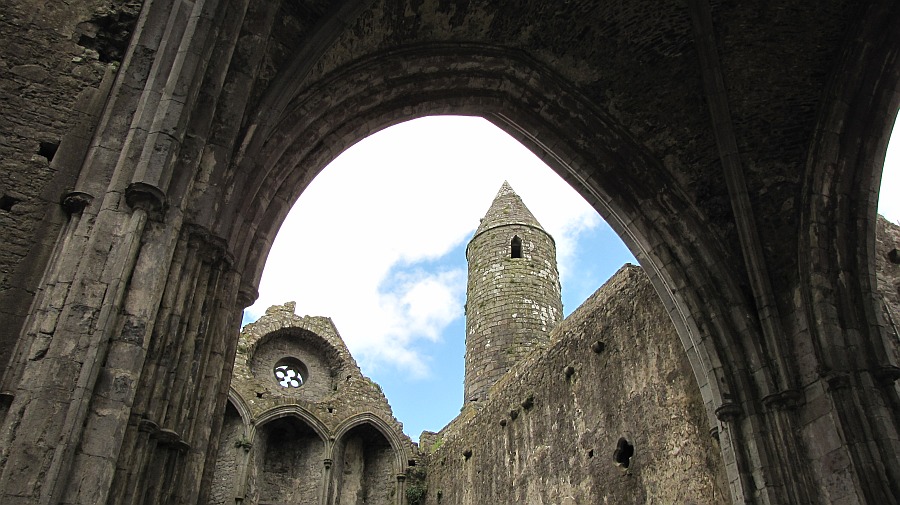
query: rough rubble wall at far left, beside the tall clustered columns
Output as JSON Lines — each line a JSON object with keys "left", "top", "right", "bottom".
{"left": 0, "top": 0, "right": 141, "bottom": 370}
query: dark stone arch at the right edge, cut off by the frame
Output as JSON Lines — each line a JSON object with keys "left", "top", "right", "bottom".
{"left": 795, "top": 0, "right": 900, "bottom": 503}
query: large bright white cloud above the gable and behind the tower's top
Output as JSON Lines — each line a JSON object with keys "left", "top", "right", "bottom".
{"left": 248, "top": 117, "right": 599, "bottom": 376}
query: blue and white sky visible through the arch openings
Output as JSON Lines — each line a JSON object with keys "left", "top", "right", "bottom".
{"left": 244, "top": 112, "right": 900, "bottom": 441}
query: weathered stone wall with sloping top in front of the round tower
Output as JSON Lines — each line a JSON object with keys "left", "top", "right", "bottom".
{"left": 421, "top": 266, "right": 729, "bottom": 505}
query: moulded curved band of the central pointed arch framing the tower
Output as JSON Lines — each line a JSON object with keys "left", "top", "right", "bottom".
{"left": 217, "top": 45, "right": 748, "bottom": 423}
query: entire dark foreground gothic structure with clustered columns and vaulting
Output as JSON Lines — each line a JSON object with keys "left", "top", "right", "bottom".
{"left": 0, "top": 0, "right": 900, "bottom": 504}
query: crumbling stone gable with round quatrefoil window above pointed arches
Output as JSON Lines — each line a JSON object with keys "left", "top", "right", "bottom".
{"left": 208, "top": 302, "right": 415, "bottom": 505}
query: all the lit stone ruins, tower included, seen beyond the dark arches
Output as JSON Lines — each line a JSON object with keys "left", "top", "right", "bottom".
{"left": 209, "top": 183, "right": 900, "bottom": 505}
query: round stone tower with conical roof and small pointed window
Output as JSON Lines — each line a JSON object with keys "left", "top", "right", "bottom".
{"left": 465, "top": 182, "right": 562, "bottom": 403}
